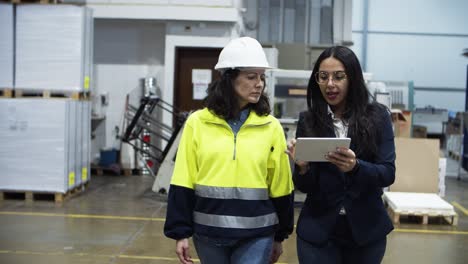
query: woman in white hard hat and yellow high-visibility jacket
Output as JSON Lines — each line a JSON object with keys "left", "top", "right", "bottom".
{"left": 164, "top": 37, "right": 294, "bottom": 264}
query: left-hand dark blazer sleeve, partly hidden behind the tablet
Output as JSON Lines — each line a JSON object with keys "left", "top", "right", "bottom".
{"left": 293, "top": 112, "right": 318, "bottom": 193}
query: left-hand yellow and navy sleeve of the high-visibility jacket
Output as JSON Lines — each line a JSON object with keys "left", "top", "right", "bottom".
{"left": 164, "top": 118, "right": 197, "bottom": 240}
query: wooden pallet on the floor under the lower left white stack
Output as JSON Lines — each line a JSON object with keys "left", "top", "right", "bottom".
{"left": 0, "top": 182, "right": 89, "bottom": 204}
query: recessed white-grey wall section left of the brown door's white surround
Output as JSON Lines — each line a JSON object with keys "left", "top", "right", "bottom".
{"left": 92, "top": 19, "right": 165, "bottom": 157}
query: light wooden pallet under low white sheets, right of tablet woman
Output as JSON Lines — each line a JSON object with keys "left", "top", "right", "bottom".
{"left": 387, "top": 207, "right": 458, "bottom": 226}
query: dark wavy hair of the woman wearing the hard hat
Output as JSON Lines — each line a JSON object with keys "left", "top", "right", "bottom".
{"left": 203, "top": 69, "right": 271, "bottom": 120}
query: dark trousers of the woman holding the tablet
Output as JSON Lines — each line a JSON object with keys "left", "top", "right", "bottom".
{"left": 297, "top": 216, "right": 387, "bottom": 264}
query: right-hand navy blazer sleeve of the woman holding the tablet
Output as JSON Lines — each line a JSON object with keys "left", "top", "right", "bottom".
{"left": 352, "top": 108, "right": 395, "bottom": 188}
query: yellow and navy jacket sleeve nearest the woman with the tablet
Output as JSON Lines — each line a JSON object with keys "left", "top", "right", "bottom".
{"left": 268, "top": 119, "right": 294, "bottom": 242}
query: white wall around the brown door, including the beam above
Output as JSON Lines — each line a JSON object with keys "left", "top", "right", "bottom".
{"left": 88, "top": 0, "right": 243, "bottom": 164}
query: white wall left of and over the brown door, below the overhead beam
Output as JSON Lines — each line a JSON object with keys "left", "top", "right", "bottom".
{"left": 93, "top": 19, "right": 239, "bottom": 156}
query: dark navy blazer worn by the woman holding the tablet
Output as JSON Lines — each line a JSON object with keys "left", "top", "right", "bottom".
{"left": 293, "top": 106, "right": 395, "bottom": 245}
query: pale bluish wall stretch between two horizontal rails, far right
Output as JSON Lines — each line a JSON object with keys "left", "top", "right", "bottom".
{"left": 367, "top": 34, "right": 468, "bottom": 88}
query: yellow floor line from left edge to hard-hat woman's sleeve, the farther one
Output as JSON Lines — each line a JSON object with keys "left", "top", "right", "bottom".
{"left": 0, "top": 211, "right": 166, "bottom": 222}
